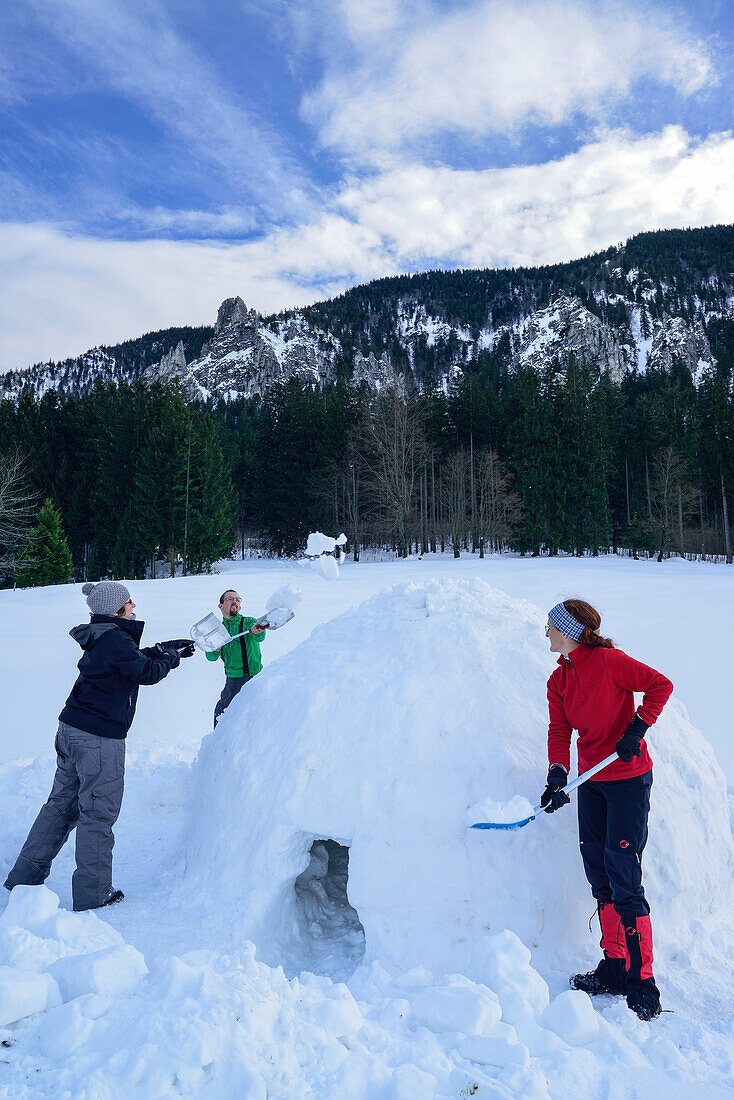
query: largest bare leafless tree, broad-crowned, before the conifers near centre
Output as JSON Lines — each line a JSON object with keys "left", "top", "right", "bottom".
{"left": 357, "top": 381, "right": 426, "bottom": 558}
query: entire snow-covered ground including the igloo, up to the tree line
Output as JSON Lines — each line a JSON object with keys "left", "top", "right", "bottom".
{"left": 0, "top": 557, "right": 734, "bottom": 1100}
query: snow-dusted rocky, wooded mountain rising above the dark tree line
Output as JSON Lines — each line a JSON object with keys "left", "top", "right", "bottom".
{"left": 0, "top": 226, "right": 734, "bottom": 399}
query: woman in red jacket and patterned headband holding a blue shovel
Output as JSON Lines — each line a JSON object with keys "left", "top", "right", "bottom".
{"left": 540, "top": 600, "right": 672, "bottom": 1020}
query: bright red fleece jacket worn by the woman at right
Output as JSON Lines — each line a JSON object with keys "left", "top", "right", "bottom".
{"left": 548, "top": 646, "right": 672, "bottom": 782}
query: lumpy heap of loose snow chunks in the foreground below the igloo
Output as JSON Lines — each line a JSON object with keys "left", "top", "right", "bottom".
{"left": 0, "top": 887, "right": 726, "bottom": 1100}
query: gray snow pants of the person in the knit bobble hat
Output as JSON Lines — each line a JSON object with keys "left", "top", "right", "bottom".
{"left": 6, "top": 722, "right": 125, "bottom": 910}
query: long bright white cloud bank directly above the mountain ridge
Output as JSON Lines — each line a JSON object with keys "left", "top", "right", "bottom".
{"left": 0, "top": 127, "right": 734, "bottom": 370}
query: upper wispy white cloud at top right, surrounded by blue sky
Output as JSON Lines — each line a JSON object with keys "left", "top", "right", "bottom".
{"left": 303, "top": 0, "right": 712, "bottom": 161}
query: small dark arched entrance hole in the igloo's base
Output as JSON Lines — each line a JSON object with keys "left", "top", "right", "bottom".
{"left": 295, "top": 840, "right": 364, "bottom": 978}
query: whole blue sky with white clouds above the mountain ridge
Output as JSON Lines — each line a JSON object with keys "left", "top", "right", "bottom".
{"left": 0, "top": 0, "right": 734, "bottom": 370}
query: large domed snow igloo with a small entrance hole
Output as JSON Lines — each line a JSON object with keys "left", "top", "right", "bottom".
{"left": 178, "top": 580, "right": 734, "bottom": 980}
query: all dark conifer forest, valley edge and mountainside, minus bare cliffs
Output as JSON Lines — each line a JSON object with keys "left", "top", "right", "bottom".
{"left": 0, "top": 226, "right": 734, "bottom": 584}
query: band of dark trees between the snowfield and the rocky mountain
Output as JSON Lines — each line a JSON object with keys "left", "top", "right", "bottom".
{"left": 0, "top": 341, "right": 734, "bottom": 583}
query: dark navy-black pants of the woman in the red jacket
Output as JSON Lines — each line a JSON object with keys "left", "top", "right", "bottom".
{"left": 579, "top": 771, "right": 653, "bottom": 916}
